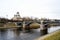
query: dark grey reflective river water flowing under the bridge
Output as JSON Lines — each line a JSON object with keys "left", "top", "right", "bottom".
{"left": 0, "top": 26, "right": 60, "bottom": 40}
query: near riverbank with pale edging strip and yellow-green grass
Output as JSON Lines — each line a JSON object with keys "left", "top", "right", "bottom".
{"left": 36, "top": 30, "right": 60, "bottom": 40}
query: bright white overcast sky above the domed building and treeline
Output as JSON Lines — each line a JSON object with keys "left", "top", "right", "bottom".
{"left": 0, "top": 0, "right": 60, "bottom": 19}
